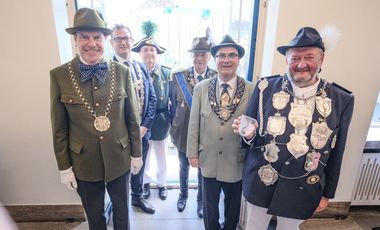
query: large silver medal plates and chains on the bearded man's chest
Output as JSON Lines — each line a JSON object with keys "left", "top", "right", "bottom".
{"left": 258, "top": 78, "right": 332, "bottom": 186}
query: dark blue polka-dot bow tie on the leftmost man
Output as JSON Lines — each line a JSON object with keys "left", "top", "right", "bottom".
{"left": 79, "top": 62, "right": 108, "bottom": 83}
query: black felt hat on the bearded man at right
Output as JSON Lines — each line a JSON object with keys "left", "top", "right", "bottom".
{"left": 277, "top": 27, "right": 325, "bottom": 55}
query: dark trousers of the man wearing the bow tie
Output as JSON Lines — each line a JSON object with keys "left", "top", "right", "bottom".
{"left": 77, "top": 171, "right": 129, "bottom": 230}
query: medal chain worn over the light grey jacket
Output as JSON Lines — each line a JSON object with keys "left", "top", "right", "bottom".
{"left": 208, "top": 77, "right": 245, "bottom": 122}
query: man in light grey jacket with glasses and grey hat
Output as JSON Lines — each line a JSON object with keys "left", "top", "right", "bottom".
{"left": 186, "top": 35, "right": 253, "bottom": 230}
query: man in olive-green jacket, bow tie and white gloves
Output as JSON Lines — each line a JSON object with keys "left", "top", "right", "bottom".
{"left": 50, "top": 8, "right": 142, "bottom": 230}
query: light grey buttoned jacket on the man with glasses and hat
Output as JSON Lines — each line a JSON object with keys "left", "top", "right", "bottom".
{"left": 187, "top": 76, "right": 253, "bottom": 183}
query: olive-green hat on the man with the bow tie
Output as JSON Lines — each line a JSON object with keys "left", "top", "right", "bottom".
{"left": 66, "top": 8, "right": 112, "bottom": 35}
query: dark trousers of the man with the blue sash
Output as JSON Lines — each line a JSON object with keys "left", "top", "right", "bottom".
{"left": 178, "top": 151, "right": 202, "bottom": 202}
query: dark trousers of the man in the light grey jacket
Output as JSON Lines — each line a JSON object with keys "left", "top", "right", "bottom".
{"left": 202, "top": 177, "right": 242, "bottom": 230}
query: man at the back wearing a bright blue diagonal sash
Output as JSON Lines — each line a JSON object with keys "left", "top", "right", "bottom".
{"left": 170, "top": 37, "right": 217, "bottom": 218}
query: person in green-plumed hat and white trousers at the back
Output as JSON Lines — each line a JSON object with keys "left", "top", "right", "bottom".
{"left": 132, "top": 21, "right": 171, "bottom": 200}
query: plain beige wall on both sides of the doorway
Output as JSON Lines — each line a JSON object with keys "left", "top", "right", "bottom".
{"left": 0, "top": 0, "right": 380, "bottom": 205}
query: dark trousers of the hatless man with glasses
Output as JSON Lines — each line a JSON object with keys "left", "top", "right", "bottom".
{"left": 131, "top": 138, "right": 149, "bottom": 199}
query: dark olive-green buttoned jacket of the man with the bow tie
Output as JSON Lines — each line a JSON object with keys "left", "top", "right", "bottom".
{"left": 50, "top": 57, "right": 141, "bottom": 181}
